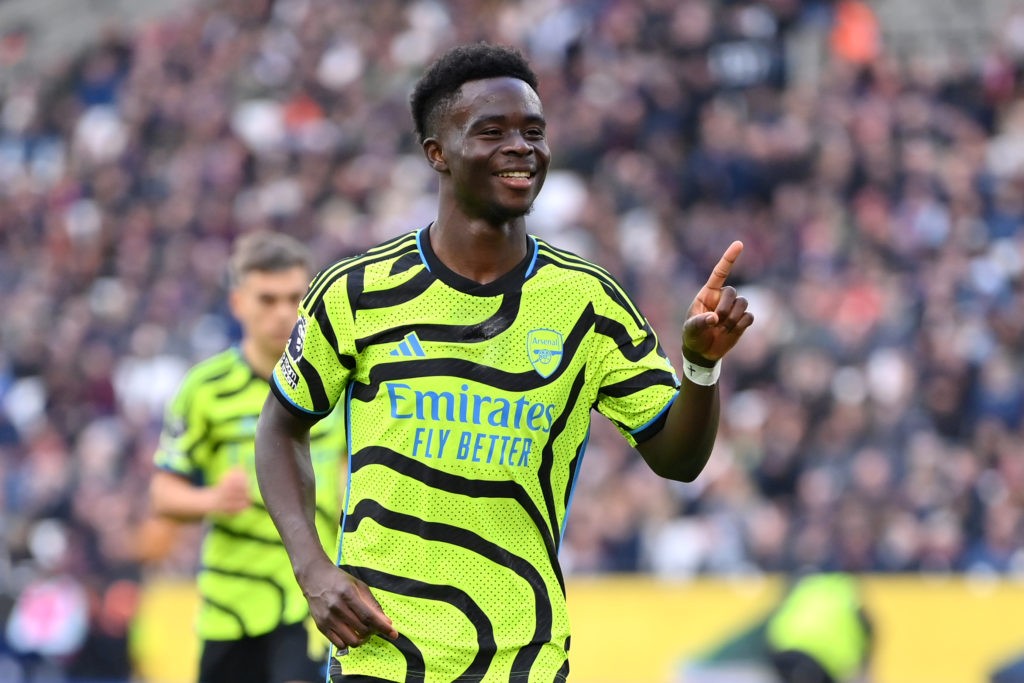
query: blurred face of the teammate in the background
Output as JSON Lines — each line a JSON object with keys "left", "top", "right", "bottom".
{"left": 231, "top": 266, "right": 309, "bottom": 355}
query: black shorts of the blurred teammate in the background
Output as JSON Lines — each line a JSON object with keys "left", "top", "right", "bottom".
{"left": 199, "top": 623, "right": 326, "bottom": 683}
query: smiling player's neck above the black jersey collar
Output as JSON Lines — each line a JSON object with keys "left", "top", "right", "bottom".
{"left": 427, "top": 217, "right": 526, "bottom": 285}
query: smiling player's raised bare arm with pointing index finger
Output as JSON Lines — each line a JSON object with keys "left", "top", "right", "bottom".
{"left": 637, "top": 242, "right": 754, "bottom": 481}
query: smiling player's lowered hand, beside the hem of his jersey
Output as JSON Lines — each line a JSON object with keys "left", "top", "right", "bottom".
{"left": 301, "top": 556, "right": 398, "bottom": 649}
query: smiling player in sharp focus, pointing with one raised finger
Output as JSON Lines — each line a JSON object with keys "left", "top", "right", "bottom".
{"left": 256, "top": 44, "right": 753, "bottom": 683}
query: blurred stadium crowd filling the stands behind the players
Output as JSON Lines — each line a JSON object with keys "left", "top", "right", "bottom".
{"left": 0, "top": 0, "right": 1024, "bottom": 680}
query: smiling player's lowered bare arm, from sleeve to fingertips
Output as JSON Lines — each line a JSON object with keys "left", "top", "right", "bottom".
{"left": 256, "top": 393, "right": 398, "bottom": 648}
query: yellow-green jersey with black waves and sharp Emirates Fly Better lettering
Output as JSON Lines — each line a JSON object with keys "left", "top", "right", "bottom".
{"left": 271, "top": 228, "right": 678, "bottom": 683}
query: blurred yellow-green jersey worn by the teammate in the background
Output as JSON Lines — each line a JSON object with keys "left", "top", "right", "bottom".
{"left": 155, "top": 348, "right": 346, "bottom": 640}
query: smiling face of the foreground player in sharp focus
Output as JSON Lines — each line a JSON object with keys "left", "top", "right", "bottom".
{"left": 439, "top": 78, "right": 551, "bottom": 223}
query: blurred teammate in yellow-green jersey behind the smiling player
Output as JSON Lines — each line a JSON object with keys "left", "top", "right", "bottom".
{"left": 151, "top": 232, "right": 345, "bottom": 683}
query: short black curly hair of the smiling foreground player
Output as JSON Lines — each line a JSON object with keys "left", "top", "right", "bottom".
{"left": 410, "top": 42, "right": 538, "bottom": 142}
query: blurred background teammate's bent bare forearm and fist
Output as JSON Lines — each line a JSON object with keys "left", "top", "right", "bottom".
{"left": 150, "top": 469, "right": 252, "bottom": 521}
